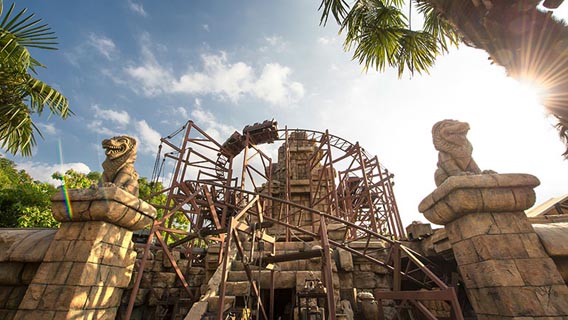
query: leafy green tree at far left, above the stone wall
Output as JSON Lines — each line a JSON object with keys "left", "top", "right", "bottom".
{"left": 0, "top": 158, "right": 59, "bottom": 228}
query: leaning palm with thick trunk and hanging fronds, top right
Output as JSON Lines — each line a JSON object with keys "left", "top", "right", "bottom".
{"left": 320, "top": 0, "right": 568, "bottom": 157}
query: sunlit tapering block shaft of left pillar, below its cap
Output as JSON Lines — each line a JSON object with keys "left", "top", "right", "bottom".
{"left": 16, "top": 190, "right": 142, "bottom": 319}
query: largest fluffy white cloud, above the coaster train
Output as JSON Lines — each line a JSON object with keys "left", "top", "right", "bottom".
{"left": 124, "top": 39, "right": 304, "bottom": 105}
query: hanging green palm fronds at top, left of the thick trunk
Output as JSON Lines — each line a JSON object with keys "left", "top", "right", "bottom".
{"left": 320, "top": 0, "right": 459, "bottom": 77}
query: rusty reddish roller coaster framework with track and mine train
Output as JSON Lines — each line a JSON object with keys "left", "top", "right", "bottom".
{"left": 126, "top": 121, "right": 463, "bottom": 320}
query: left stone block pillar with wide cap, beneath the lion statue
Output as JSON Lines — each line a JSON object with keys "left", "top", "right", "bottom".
{"left": 15, "top": 187, "right": 156, "bottom": 319}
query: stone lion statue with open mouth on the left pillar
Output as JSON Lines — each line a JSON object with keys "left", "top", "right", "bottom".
{"left": 101, "top": 136, "right": 139, "bottom": 197}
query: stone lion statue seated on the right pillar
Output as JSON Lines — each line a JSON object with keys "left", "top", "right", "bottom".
{"left": 432, "top": 120, "right": 494, "bottom": 186}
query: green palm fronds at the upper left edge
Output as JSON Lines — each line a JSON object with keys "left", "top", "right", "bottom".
{"left": 0, "top": 0, "right": 71, "bottom": 156}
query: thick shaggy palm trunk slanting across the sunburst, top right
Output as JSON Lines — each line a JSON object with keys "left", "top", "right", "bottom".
{"left": 424, "top": 0, "right": 568, "bottom": 155}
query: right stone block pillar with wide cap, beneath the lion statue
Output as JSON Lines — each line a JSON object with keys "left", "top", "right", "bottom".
{"left": 419, "top": 174, "right": 568, "bottom": 319}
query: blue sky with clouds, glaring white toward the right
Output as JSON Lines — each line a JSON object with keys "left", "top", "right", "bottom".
{"left": 5, "top": 0, "right": 568, "bottom": 224}
